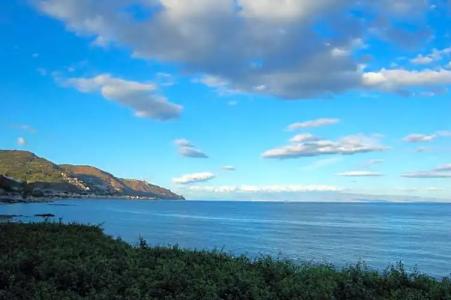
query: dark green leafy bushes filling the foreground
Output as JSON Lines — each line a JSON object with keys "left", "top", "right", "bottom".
{"left": 0, "top": 222, "right": 451, "bottom": 299}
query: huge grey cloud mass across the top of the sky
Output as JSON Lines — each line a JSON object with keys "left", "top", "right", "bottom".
{"left": 35, "top": 0, "right": 442, "bottom": 99}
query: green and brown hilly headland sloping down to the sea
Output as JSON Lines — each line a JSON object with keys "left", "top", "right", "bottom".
{"left": 0, "top": 150, "right": 184, "bottom": 200}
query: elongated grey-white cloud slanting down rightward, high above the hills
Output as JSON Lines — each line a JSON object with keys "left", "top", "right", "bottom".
{"left": 62, "top": 74, "right": 182, "bottom": 120}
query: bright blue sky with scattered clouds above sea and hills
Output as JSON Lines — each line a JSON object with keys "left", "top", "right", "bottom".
{"left": 0, "top": 0, "right": 451, "bottom": 201}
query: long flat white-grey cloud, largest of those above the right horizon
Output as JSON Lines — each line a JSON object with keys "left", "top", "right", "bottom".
{"left": 262, "top": 135, "right": 386, "bottom": 159}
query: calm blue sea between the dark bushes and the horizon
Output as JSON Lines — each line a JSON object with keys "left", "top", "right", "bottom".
{"left": 0, "top": 200, "right": 451, "bottom": 277}
